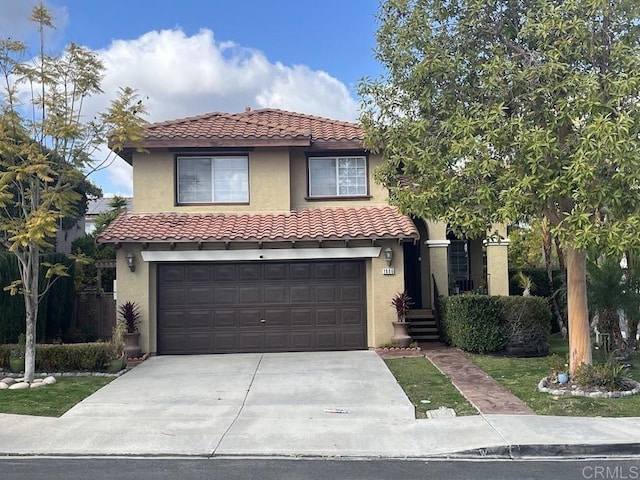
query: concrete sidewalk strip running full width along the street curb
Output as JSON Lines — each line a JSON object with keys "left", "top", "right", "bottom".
{"left": 0, "top": 411, "right": 640, "bottom": 458}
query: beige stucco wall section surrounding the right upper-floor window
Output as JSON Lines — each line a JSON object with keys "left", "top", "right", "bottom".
{"left": 291, "top": 149, "right": 388, "bottom": 209}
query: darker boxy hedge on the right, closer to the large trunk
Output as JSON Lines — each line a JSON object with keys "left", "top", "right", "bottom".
{"left": 500, "top": 297, "right": 551, "bottom": 356}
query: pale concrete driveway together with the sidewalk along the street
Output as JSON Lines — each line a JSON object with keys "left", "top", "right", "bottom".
{"left": 0, "top": 352, "right": 640, "bottom": 458}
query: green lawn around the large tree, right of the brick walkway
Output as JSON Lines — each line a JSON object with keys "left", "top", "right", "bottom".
{"left": 468, "top": 337, "right": 640, "bottom": 417}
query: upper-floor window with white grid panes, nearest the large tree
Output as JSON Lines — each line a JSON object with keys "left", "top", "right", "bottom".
{"left": 309, "top": 157, "right": 367, "bottom": 197}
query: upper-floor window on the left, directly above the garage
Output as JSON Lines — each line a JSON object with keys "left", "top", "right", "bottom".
{"left": 177, "top": 157, "right": 249, "bottom": 203}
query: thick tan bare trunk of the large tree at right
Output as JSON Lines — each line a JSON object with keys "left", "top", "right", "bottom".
{"left": 567, "top": 248, "right": 591, "bottom": 375}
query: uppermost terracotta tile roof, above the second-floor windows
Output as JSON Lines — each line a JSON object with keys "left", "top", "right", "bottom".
{"left": 136, "top": 109, "right": 364, "bottom": 141}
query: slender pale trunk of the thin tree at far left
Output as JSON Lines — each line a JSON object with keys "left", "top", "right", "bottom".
{"left": 22, "top": 246, "right": 40, "bottom": 383}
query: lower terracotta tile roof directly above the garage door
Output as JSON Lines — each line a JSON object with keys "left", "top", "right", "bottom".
{"left": 97, "top": 205, "right": 419, "bottom": 243}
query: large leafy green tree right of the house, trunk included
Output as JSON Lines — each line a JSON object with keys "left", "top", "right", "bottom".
{"left": 360, "top": 0, "right": 640, "bottom": 373}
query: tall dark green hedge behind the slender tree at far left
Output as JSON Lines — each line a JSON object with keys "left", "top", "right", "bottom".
{"left": 0, "top": 252, "right": 75, "bottom": 343}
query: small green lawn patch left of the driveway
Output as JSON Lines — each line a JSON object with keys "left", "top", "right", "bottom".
{"left": 0, "top": 377, "right": 114, "bottom": 417}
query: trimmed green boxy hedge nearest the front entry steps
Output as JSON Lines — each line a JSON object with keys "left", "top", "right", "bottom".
{"left": 442, "top": 295, "right": 505, "bottom": 353}
